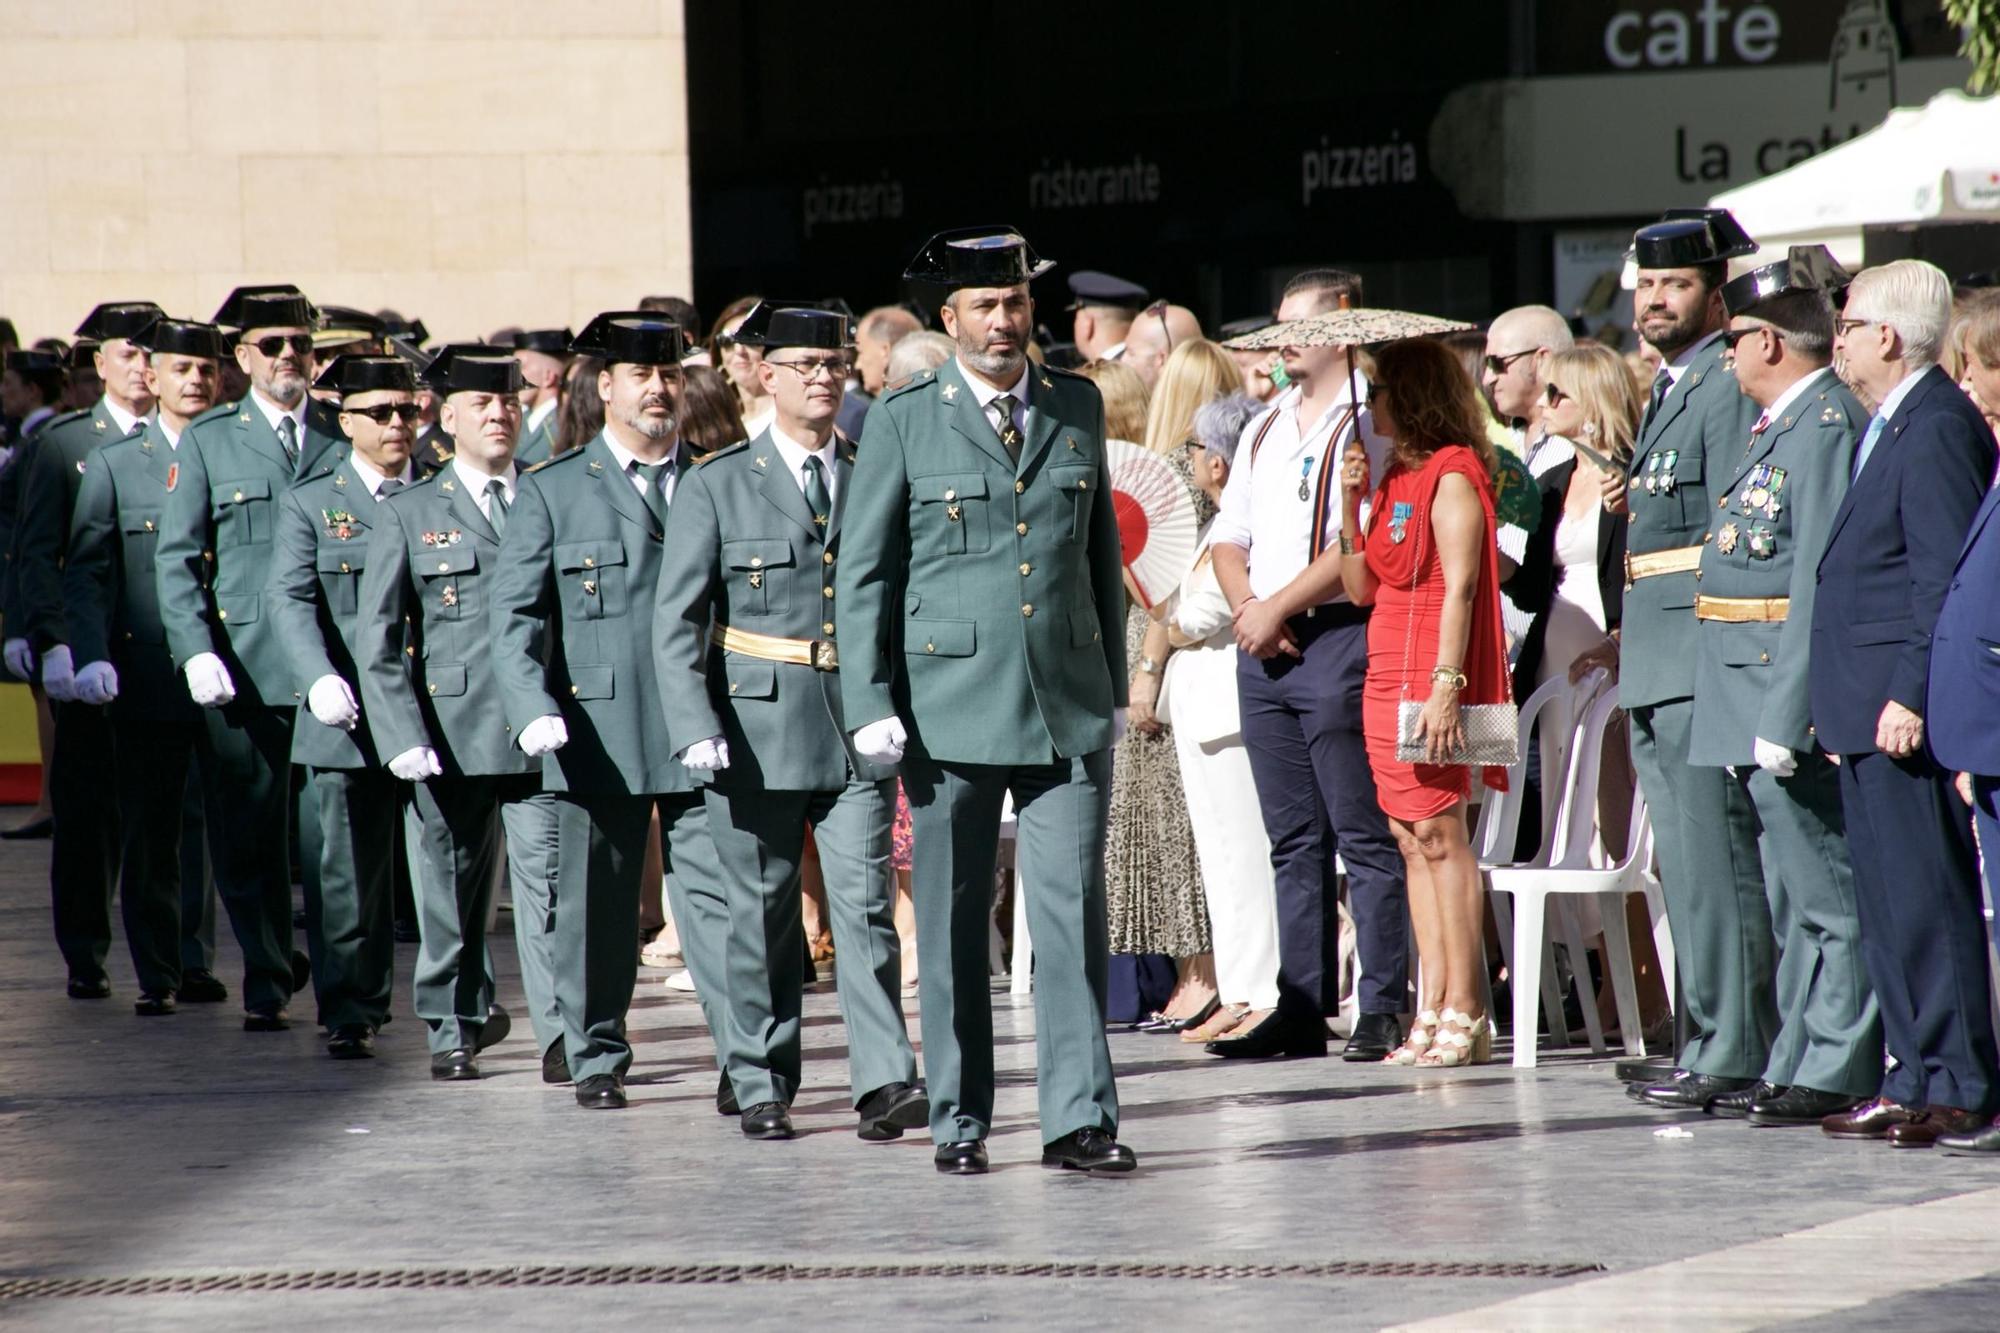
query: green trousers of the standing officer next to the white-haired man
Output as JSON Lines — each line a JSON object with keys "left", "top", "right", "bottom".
{"left": 1736, "top": 751, "right": 1882, "bottom": 1097}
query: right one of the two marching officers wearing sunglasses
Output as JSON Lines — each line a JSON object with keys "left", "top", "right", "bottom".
{"left": 266, "top": 354, "right": 416, "bottom": 1061}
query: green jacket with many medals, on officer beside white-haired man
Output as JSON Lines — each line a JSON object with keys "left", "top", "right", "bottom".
{"left": 1688, "top": 370, "right": 1868, "bottom": 765}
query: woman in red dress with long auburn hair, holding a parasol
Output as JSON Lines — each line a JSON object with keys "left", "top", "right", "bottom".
{"left": 1340, "top": 338, "right": 1512, "bottom": 1067}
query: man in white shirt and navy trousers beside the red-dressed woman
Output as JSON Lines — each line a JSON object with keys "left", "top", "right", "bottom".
{"left": 1208, "top": 268, "right": 1410, "bottom": 1061}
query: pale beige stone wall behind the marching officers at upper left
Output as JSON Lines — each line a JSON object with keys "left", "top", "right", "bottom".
{"left": 0, "top": 0, "right": 692, "bottom": 340}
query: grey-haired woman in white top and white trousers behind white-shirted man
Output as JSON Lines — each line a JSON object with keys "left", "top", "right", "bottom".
{"left": 1158, "top": 394, "right": 1278, "bottom": 1041}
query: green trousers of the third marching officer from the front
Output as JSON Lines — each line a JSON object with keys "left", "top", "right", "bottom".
{"left": 550, "top": 791, "right": 728, "bottom": 1081}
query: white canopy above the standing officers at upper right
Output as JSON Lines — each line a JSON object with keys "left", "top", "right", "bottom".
{"left": 1708, "top": 90, "right": 2000, "bottom": 268}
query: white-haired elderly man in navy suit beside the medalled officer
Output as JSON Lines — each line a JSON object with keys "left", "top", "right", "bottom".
{"left": 1812, "top": 260, "right": 2000, "bottom": 1147}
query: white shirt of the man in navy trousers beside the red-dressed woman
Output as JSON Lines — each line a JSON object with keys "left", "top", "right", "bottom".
{"left": 1212, "top": 374, "right": 1392, "bottom": 602}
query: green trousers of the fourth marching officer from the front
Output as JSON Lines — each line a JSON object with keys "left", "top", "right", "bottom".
{"left": 408, "top": 773, "right": 562, "bottom": 1055}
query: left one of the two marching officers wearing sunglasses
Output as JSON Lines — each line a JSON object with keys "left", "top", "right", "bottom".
{"left": 158, "top": 286, "right": 340, "bottom": 1033}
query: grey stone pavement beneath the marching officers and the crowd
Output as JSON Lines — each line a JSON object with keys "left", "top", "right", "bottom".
{"left": 0, "top": 815, "right": 2000, "bottom": 1333}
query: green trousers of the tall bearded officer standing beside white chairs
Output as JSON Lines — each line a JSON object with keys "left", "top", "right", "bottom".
{"left": 1632, "top": 699, "right": 1778, "bottom": 1079}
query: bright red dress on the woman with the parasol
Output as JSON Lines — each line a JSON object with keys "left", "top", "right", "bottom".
{"left": 1362, "top": 444, "right": 1512, "bottom": 823}
